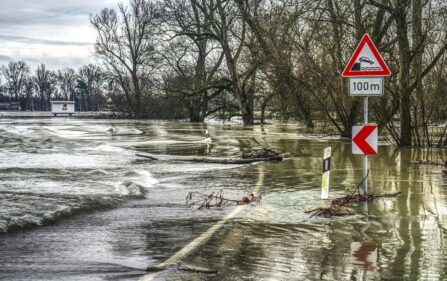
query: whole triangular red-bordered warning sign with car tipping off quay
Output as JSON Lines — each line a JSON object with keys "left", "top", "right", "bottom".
{"left": 342, "top": 34, "right": 391, "bottom": 77}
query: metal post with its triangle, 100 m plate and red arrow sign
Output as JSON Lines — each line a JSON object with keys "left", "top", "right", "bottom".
{"left": 342, "top": 34, "right": 391, "bottom": 194}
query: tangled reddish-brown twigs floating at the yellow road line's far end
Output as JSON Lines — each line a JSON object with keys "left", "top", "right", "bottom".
{"left": 186, "top": 190, "right": 261, "bottom": 210}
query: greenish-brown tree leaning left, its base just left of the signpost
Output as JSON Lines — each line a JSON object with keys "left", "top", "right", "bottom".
{"left": 235, "top": 0, "right": 316, "bottom": 128}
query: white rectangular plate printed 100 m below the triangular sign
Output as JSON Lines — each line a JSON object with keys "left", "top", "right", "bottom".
{"left": 349, "top": 77, "right": 383, "bottom": 96}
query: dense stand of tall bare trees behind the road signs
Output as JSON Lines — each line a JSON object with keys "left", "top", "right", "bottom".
{"left": 91, "top": 0, "right": 447, "bottom": 146}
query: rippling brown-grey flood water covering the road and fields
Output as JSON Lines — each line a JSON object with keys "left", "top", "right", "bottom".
{"left": 0, "top": 118, "right": 447, "bottom": 280}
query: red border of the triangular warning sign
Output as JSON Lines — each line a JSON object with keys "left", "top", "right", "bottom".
{"left": 342, "top": 34, "right": 391, "bottom": 77}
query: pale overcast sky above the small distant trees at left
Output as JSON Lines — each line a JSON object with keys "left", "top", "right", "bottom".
{"left": 0, "top": 0, "right": 124, "bottom": 69}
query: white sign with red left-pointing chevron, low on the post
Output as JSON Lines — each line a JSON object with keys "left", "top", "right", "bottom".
{"left": 352, "top": 125, "right": 378, "bottom": 155}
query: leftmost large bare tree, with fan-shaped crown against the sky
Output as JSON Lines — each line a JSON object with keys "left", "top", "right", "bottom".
{"left": 90, "top": 0, "right": 160, "bottom": 118}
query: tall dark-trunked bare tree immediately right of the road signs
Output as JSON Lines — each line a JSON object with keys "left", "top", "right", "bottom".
{"left": 368, "top": 0, "right": 447, "bottom": 146}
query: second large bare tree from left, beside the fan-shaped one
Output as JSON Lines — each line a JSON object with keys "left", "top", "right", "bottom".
{"left": 163, "top": 0, "right": 230, "bottom": 122}
